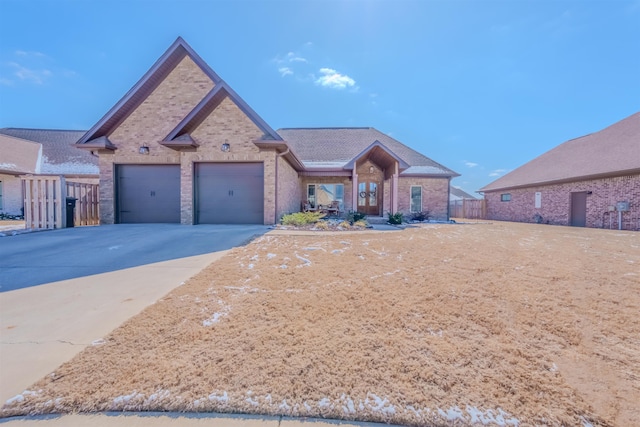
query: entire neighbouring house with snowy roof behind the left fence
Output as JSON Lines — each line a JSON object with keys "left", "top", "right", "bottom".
{"left": 0, "top": 128, "right": 98, "bottom": 215}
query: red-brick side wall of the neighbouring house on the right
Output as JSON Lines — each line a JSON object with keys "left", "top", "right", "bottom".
{"left": 485, "top": 175, "right": 640, "bottom": 231}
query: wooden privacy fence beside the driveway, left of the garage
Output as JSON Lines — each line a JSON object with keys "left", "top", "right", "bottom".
{"left": 21, "top": 175, "right": 100, "bottom": 229}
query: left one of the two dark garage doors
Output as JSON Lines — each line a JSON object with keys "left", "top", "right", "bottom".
{"left": 116, "top": 165, "right": 180, "bottom": 224}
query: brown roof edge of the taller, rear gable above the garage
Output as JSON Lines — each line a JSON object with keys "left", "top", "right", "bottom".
{"left": 77, "top": 37, "right": 222, "bottom": 144}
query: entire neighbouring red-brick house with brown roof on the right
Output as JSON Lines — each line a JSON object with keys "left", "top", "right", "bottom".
{"left": 480, "top": 112, "right": 640, "bottom": 231}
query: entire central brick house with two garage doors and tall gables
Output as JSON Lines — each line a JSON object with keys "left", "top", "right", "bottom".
{"left": 77, "top": 38, "right": 457, "bottom": 224}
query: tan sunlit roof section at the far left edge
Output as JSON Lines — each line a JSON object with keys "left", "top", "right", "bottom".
{"left": 0, "top": 134, "right": 42, "bottom": 175}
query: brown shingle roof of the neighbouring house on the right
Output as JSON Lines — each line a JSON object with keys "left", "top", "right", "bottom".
{"left": 480, "top": 112, "right": 640, "bottom": 191}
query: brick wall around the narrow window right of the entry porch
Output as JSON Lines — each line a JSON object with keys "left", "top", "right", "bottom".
{"left": 398, "top": 176, "right": 449, "bottom": 221}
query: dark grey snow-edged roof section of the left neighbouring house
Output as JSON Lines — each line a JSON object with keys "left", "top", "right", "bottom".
{"left": 0, "top": 128, "right": 100, "bottom": 175}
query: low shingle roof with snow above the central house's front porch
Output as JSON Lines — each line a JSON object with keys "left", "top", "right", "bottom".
{"left": 278, "top": 127, "right": 459, "bottom": 177}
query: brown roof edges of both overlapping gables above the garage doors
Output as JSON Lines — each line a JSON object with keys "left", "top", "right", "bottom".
{"left": 78, "top": 37, "right": 279, "bottom": 145}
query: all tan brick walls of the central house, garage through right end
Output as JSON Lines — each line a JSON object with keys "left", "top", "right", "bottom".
{"left": 85, "top": 41, "right": 456, "bottom": 224}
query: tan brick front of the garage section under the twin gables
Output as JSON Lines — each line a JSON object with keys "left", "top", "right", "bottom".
{"left": 100, "top": 56, "right": 288, "bottom": 224}
